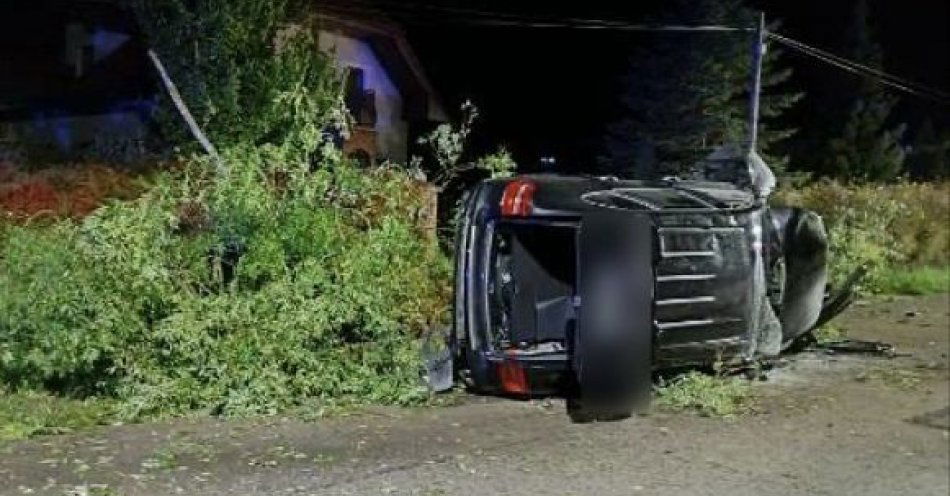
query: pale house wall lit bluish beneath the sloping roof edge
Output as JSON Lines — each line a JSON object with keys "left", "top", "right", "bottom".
{"left": 318, "top": 31, "right": 409, "bottom": 163}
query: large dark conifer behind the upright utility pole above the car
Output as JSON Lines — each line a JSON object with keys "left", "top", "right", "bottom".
{"left": 607, "top": 0, "right": 802, "bottom": 176}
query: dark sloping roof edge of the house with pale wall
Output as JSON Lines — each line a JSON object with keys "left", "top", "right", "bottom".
{"left": 315, "top": 3, "right": 448, "bottom": 121}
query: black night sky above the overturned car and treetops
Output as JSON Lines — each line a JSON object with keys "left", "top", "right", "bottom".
{"left": 376, "top": 0, "right": 950, "bottom": 168}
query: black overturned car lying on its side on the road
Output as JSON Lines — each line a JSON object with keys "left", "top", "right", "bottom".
{"left": 449, "top": 149, "right": 860, "bottom": 418}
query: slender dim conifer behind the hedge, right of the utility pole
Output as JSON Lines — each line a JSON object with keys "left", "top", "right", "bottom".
{"left": 825, "top": 0, "right": 906, "bottom": 181}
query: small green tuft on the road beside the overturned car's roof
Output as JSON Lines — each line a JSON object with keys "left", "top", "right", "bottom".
{"left": 657, "top": 372, "right": 755, "bottom": 417}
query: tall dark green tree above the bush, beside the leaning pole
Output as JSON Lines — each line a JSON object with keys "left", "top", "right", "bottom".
{"left": 127, "top": 0, "right": 345, "bottom": 157}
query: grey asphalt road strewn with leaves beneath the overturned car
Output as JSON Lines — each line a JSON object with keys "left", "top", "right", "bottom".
{"left": 0, "top": 295, "right": 950, "bottom": 496}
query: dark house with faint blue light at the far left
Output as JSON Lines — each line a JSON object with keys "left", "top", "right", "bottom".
{"left": 0, "top": 0, "right": 155, "bottom": 159}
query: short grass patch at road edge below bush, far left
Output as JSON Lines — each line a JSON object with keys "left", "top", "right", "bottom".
{"left": 0, "top": 392, "right": 115, "bottom": 443}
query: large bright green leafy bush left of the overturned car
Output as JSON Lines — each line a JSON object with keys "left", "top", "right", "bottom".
{"left": 0, "top": 147, "right": 449, "bottom": 418}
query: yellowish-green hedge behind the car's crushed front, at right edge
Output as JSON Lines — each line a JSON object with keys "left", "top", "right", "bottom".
{"left": 775, "top": 182, "right": 950, "bottom": 291}
